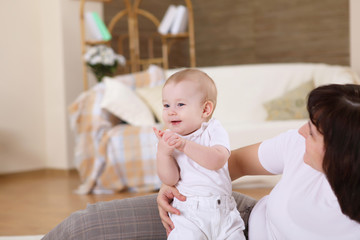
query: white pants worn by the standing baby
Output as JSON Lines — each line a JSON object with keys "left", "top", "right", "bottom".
{"left": 168, "top": 195, "right": 245, "bottom": 240}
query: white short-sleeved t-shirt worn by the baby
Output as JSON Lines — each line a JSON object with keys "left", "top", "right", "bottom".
{"left": 174, "top": 119, "right": 232, "bottom": 197}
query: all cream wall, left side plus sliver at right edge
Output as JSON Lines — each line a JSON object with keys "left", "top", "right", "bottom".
{"left": 0, "top": 0, "right": 360, "bottom": 173}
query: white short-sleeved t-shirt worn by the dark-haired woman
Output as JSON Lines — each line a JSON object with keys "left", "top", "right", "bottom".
{"left": 249, "top": 130, "right": 360, "bottom": 240}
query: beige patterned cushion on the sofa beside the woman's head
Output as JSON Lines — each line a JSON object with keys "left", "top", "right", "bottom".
{"left": 264, "top": 80, "right": 314, "bottom": 120}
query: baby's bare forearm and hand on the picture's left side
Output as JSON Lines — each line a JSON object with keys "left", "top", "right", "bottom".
{"left": 154, "top": 128, "right": 180, "bottom": 186}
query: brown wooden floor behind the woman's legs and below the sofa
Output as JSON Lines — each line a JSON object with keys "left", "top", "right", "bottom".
{"left": 0, "top": 170, "right": 271, "bottom": 236}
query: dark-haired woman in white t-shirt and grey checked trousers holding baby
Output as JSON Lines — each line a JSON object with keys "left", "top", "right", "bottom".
{"left": 44, "top": 84, "right": 360, "bottom": 239}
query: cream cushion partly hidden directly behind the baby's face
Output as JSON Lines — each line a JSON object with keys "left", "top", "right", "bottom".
{"left": 135, "top": 85, "right": 164, "bottom": 123}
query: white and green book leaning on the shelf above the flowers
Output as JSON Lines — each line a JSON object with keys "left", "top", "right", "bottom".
{"left": 85, "top": 12, "right": 111, "bottom": 41}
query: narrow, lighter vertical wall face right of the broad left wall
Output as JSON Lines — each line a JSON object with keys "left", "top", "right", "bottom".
{"left": 40, "top": 0, "right": 69, "bottom": 168}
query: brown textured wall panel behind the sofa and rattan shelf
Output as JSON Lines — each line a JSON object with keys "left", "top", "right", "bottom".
{"left": 104, "top": 0, "right": 350, "bottom": 67}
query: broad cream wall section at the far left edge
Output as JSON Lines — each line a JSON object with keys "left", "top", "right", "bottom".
{"left": 0, "top": 0, "right": 46, "bottom": 172}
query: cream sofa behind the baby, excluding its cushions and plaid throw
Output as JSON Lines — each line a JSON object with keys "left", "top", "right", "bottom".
{"left": 166, "top": 63, "right": 359, "bottom": 188}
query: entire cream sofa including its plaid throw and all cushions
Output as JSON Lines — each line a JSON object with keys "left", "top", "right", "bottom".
{"left": 71, "top": 63, "right": 359, "bottom": 193}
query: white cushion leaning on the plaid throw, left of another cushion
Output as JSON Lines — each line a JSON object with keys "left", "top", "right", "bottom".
{"left": 101, "top": 77, "right": 155, "bottom": 126}
